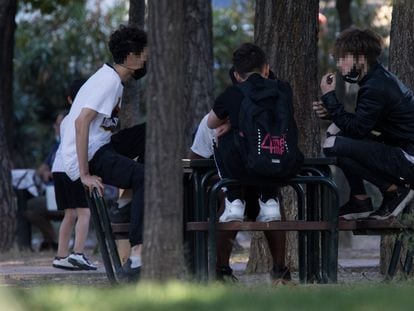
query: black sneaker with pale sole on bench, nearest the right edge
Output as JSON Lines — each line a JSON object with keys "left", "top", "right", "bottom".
{"left": 370, "top": 186, "right": 414, "bottom": 219}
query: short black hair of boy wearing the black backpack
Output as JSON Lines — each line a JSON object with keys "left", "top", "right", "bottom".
{"left": 233, "top": 43, "right": 267, "bottom": 78}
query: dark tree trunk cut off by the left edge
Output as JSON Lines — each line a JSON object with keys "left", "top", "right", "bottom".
{"left": 0, "top": 0, "right": 17, "bottom": 251}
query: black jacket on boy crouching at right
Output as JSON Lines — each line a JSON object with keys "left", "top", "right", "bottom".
{"left": 322, "top": 63, "right": 414, "bottom": 154}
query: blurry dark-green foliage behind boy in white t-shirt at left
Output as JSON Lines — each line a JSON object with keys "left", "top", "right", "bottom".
{"left": 14, "top": 0, "right": 126, "bottom": 166}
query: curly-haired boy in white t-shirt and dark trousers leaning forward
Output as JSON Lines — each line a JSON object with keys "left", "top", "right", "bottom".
{"left": 55, "top": 26, "right": 147, "bottom": 280}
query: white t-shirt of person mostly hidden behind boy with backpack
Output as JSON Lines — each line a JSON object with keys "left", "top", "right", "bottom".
{"left": 191, "top": 114, "right": 216, "bottom": 159}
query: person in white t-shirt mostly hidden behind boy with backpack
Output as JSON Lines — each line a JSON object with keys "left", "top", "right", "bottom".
{"left": 190, "top": 67, "right": 291, "bottom": 281}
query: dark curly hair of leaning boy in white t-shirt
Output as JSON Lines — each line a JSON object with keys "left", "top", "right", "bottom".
{"left": 108, "top": 25, "right": 147, "bottom": 64}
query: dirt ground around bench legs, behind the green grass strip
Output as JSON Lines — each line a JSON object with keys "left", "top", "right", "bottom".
{"left": 0, "top": 237, "right": 384, "bottom": 288}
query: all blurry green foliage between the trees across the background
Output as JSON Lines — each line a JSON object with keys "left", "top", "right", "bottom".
{"left": 14, "top": 0, "right": 391, "bottom": 166}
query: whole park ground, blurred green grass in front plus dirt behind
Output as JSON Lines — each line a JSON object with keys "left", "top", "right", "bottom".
{"left": 0, "top": 238, "right": 414, "bottom": 311}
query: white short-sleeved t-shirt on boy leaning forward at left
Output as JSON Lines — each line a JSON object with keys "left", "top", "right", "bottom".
{"left": 52, "top": 64, "right": 123, "bottom": 180}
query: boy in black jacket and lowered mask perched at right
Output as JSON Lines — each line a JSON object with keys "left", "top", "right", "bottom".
{"left": 313, "top": 28, "right": 414, "bottom": 220}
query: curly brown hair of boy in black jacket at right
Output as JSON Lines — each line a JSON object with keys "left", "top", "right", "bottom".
{"left": 333, "top": 27, "right": 382, "bottom": 65}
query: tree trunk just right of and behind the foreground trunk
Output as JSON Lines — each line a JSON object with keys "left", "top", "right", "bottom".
{"left": 183, "top": 0, "right": 214, "bottom": 155}
